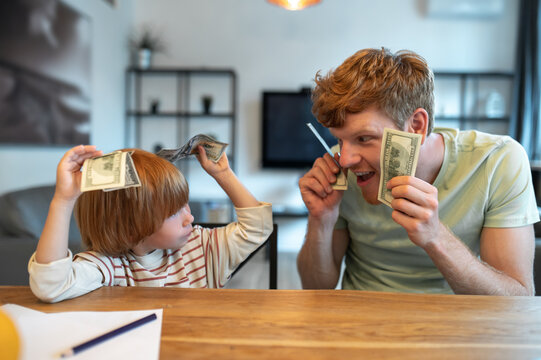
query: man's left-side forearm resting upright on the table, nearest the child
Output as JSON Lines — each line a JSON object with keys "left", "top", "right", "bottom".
{"left": 297, "top": 218, "right": 349, "bottom": 289}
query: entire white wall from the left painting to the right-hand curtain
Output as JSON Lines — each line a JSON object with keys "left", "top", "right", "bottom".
{"left": 0, "top": 0, "right": 518, "bottom": 211}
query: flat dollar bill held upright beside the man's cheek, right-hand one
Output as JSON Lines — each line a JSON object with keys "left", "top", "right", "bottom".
{"left": 378, "top": 128, "right": 423, "bottom": 206}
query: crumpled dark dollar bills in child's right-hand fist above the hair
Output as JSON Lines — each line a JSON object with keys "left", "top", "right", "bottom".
{"left": 156, "top": 134, "right": 229, "bottom": 162}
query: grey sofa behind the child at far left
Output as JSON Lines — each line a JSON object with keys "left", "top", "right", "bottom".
{"left": 0, "top": 185, "right": 82, "bottom": 285}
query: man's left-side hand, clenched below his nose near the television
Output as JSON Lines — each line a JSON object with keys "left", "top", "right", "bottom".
{"left": 299, "top": 154, "right": 344, "bottom": 218}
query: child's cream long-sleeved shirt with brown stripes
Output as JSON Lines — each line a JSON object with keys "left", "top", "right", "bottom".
{"left": 28, "top": 203, "right": 272, "bottom": 302}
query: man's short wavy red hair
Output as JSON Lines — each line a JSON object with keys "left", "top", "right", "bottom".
{"left": 312, "top": 48, "right": 434, "bottom": 135}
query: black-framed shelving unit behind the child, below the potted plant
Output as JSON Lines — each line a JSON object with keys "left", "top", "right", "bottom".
{"left": 125, "top": 68, "right": 237, "bottom": 222}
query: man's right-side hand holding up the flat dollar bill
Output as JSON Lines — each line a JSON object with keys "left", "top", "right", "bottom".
{"left": 387, "top": 176, "right": 440, "bottom": 249}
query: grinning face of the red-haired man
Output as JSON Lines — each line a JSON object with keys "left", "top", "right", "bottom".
{"left": 329, "top": 107, "right": 400, "bottom": 205}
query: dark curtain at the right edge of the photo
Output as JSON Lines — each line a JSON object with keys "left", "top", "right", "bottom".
{"left": 509, "top": 0, "right": 541, "bottom": 160}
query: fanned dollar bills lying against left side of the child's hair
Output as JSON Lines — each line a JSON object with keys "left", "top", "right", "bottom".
{"left": 81, "top": 151, "right": 141, "bottom": 192}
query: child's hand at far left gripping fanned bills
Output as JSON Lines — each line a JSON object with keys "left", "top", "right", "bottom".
{"left": 55, "top": 145, "right": 103, "bottom": 201}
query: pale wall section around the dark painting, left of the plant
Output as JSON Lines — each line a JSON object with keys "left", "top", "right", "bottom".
{"left": 0, "top": 0, "right": 133, "bottom": 194}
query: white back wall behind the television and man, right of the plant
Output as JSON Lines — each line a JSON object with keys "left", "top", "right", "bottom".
{"left": 129, "top": 0, "right": 518, "bottom": 206}
